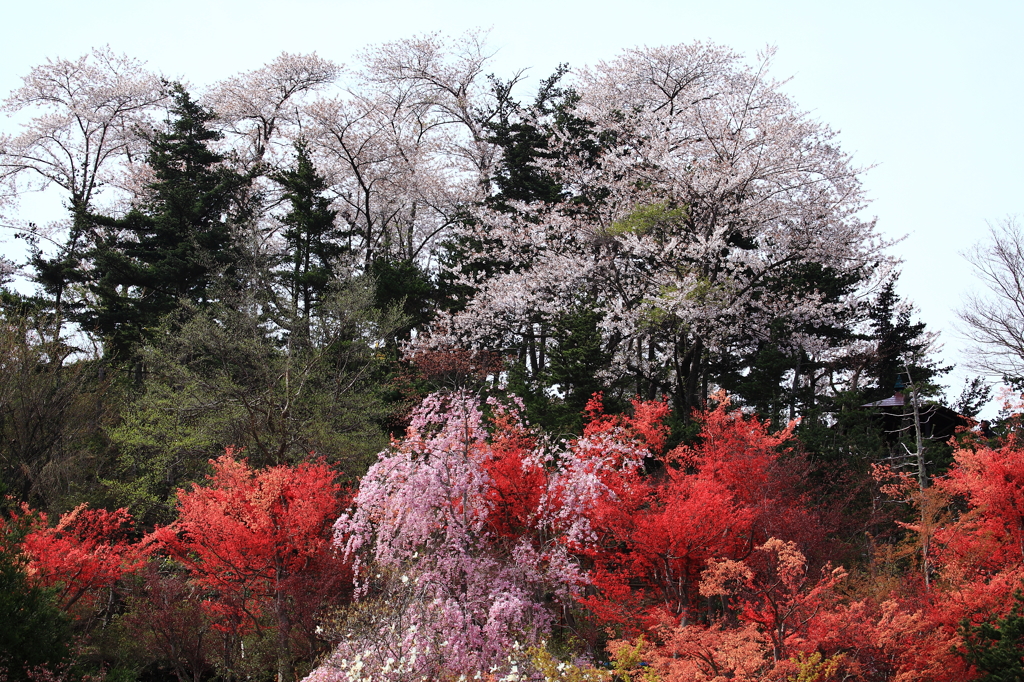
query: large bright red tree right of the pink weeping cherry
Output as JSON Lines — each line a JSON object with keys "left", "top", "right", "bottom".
{"left": 577, "top": 396, "right": 821, "bottom": 634}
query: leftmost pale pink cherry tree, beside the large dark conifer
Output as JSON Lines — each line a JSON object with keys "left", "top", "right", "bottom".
{"left": 0, "top": 47, "right": 166, "bottom": 329}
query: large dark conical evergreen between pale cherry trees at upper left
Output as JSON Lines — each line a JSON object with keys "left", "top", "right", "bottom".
{"left": 79, "top": 83, "right": 249, "bottom": 359}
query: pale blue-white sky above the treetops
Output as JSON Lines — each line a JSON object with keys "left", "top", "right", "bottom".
{"left": 0, "top": 0, "right": 1024, "bottom": 397}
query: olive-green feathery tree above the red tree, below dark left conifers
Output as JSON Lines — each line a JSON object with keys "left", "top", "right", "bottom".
{"left": 105, "top": 281, "right": 391, "bottom": 524}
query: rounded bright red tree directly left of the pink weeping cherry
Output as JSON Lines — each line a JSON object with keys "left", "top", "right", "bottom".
{"left": 154, "top": 452, "right": 351, "bottom": 629}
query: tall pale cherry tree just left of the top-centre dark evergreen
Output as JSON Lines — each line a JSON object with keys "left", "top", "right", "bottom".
{"left": 306, "top": 33, "right": 512, "bottom": 267}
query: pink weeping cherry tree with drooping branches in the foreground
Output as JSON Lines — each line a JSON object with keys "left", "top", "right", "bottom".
{"left": 321, "top": 393, "right": 583, "bottom": 680}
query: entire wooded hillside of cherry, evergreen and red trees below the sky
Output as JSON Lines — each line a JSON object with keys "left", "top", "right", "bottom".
{"left": 0, "top": 34, "right": 1024, "bottom": 682}
